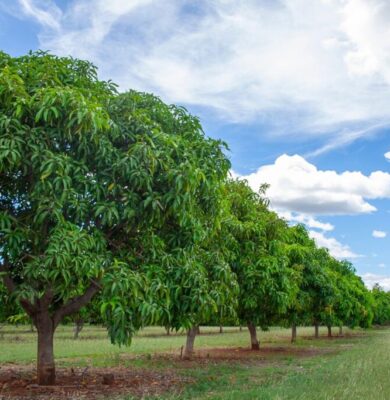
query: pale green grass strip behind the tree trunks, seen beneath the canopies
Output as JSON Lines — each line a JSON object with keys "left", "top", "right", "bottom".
{"left": 0, "top": 326, "right": 336, "bottom": 363}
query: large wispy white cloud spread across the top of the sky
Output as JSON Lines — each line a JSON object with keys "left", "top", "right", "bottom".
{"left": 7, "top": 0, "right": 390, "bottom": 146}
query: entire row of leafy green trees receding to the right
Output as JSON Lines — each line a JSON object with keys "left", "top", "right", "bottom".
{"left": 0, "top": 52, "right": 388, "bottom": 384}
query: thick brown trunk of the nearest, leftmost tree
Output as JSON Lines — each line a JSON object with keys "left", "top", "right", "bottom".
{"left": 35, "top": 311, "right": 56, "bottom": 385}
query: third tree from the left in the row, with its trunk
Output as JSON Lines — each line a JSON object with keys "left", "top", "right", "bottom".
{"left": 224, "top": 181, "right": 298, "bottom": 350}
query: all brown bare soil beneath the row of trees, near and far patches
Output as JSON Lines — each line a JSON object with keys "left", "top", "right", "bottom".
{"left": 0, "top": 346, "right": 334, "bottom": 400}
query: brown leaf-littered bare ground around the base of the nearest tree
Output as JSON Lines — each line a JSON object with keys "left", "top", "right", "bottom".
{"left": 0, "top": 364, "right": 191, "bottom": 400}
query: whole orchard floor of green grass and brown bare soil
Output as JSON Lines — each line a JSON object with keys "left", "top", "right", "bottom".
{"left": 0, "top": 326, "right": 390, "bottom": 400}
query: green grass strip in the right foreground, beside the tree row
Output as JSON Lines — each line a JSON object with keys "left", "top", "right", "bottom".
{"left": 171, "top": 330, "right": 390, "bottom": 400}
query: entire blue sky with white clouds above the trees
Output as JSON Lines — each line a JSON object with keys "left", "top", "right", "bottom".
{"left": 0, "top": 0, "right": 390, "bottom": 289}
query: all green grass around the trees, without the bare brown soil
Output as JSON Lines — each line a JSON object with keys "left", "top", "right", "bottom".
{"left": 0, "top": 326, "right": 390, "bottom": 400}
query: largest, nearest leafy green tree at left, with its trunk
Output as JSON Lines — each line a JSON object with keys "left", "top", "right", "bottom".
{"left": 0, "top": 52, "right": 229, "bottom": 384}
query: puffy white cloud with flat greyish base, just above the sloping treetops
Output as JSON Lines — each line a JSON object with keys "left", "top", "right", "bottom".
{"left": 242, "top": 154, "right": 390, "bottom": 215}
